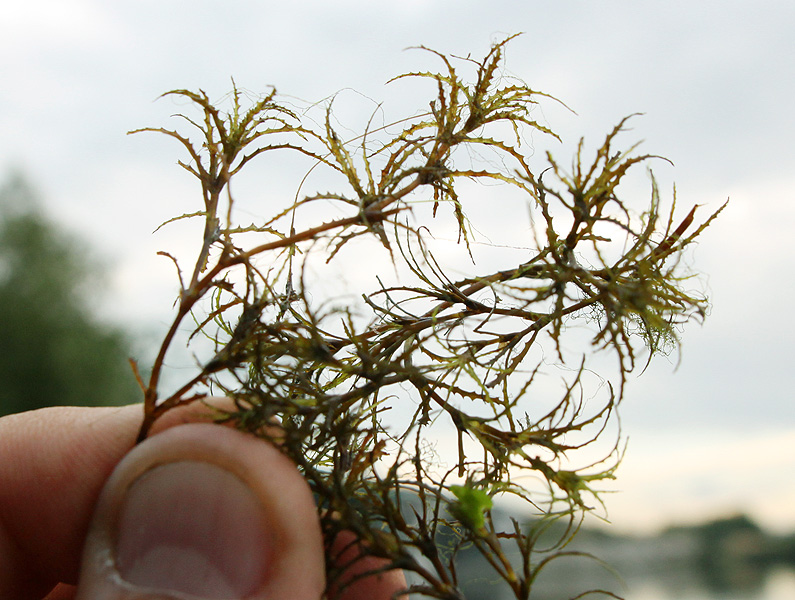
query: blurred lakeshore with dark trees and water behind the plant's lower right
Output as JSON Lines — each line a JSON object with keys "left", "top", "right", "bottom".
{"left": 412, "top": 515, "right": 795, "bottom": 600}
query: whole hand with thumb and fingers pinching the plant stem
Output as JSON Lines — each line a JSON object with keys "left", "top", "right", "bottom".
{"left": 0, "top": 406, "right": 405, "bottom": 600}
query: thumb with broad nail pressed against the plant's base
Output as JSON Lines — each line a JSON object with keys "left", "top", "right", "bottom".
{"left": 77, "top": 424, "right": 325, "bottom": 600}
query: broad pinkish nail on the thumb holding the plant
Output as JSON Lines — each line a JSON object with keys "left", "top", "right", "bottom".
{"left": 116, "top": 461, "right": 273, "bottom": 599}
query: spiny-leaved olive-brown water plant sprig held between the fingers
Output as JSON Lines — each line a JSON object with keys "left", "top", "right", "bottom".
{"left": 132, "top": 38, "right": 728, "bottom": 599}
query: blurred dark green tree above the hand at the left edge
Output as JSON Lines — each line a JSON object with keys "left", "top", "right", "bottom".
{"left": 0, "top": 175, "right": 137, "bottom": 415}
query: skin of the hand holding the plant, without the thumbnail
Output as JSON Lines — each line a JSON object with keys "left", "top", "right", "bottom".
{"left": 0, "top": 406, "right": 406, "bottom": 600}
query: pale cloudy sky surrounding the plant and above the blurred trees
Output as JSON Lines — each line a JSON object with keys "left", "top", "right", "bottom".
{"left": 0, "top": 0, "right": 795, "bottom": 529}
